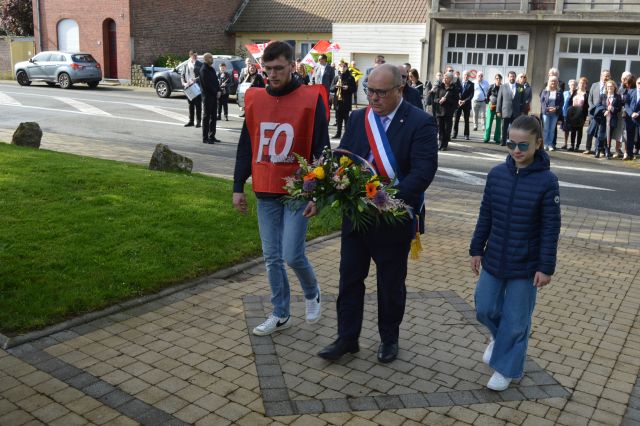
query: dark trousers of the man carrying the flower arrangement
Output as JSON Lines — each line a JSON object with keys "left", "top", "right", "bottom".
{"left": 337, "top": 221, "right": 415, "bottom": 343}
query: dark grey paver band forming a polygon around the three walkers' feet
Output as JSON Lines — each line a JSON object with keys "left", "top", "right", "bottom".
{"left": 243, "top": 291, "right": 570, "bottom": 417}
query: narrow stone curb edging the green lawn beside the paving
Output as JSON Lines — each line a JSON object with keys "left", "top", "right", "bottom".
{"left": 0, "top": 232, "right": 340, "bottom": 350}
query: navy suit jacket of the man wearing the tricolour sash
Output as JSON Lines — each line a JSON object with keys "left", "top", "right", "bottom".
{"left": 339, "top": 100, "right": 438, "bottom": 232}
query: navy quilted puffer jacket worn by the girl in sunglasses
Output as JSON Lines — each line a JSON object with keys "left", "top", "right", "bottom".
{"left": 469, "top": 150, "right": 560, "bottom": 279}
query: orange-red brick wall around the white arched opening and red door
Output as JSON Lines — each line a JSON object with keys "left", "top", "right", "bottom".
{"left": 33, "top": 0, "right": 131, "bottom": 79}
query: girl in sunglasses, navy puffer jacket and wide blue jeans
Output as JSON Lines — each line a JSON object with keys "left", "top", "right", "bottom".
{"left": 469, "top": 115, "right": 560, "bottom": 391}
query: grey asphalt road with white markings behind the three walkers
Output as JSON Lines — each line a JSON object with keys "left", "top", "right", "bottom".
{"left": 0, "top": 82, "right": 640, "bottom": 215}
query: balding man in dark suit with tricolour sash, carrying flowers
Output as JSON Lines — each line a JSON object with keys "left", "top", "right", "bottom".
{"left": 318, "top": 64, "right": 438, "bottom": 363}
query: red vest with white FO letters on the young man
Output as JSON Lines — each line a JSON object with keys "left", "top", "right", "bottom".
{"left": 245, "top": 86, "right": 319, "bottom": 194}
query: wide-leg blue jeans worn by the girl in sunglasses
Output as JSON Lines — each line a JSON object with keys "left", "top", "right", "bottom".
{"left": 475, "top": 270, "right": 537, "bottom": 379}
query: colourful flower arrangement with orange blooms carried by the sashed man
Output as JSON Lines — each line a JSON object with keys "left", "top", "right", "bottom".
{"left": 284, "top": 148, "right": 411, "bottom": 231}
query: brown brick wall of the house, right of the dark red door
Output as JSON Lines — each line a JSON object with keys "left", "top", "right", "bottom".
{"left": 130, "top": 0, "right": 242, "bottom": 66}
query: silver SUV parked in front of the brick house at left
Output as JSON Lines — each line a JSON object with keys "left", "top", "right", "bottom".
{"left": 14, "top": 51, "right": 102, "bottom": 89}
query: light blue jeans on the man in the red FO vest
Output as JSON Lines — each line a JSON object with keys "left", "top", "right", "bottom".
{"left": 258, "top": 198, "right": 318, "bottom": 318}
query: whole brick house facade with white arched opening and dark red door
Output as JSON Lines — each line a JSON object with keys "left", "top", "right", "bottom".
{"left": 33, "top": 0, "right": 243, "bottom": 81}
